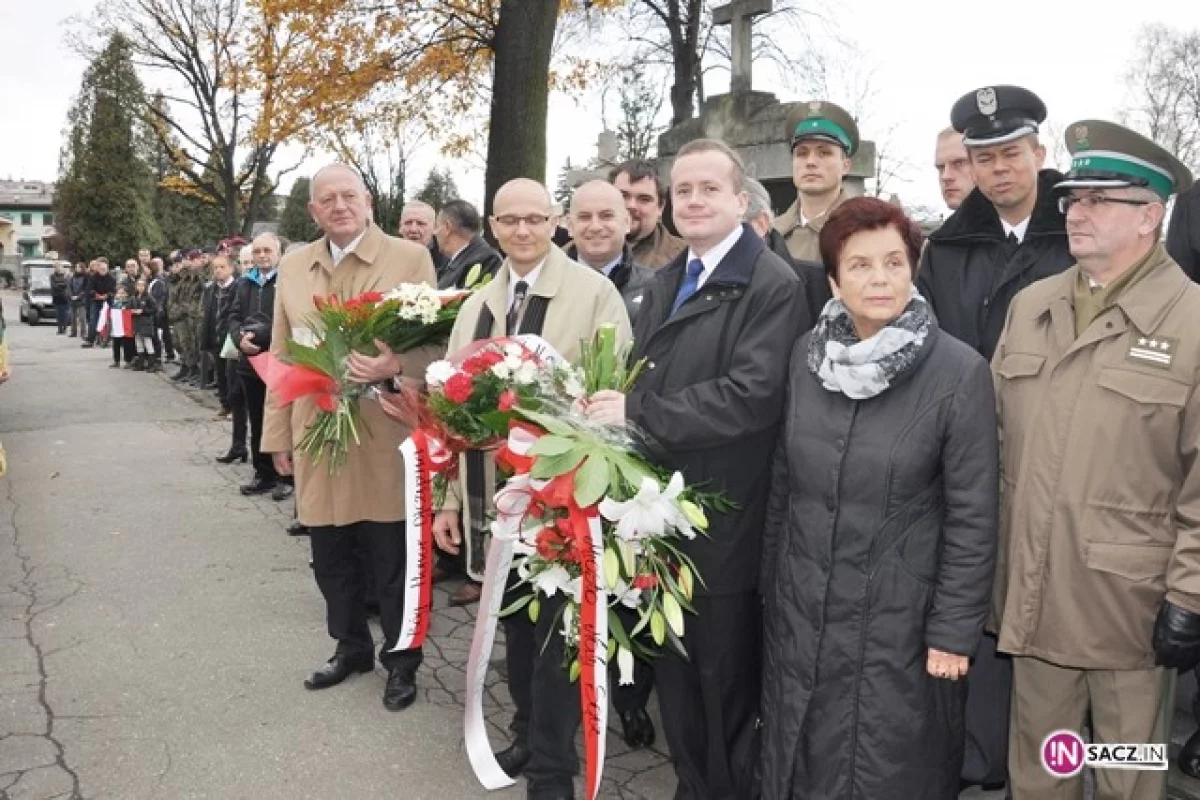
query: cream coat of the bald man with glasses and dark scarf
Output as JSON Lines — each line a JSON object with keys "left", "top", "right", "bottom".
{"left": 444, "top": 245, "right": 632, "bottom": 581}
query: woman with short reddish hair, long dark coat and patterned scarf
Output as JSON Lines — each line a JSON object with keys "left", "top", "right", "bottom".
{"left": 762, "top": 198, "right": 998, "bottom": 800}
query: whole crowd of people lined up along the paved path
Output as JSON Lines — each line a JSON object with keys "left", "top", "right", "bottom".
{"left": 28, "top": 81, "right": 1200, "bottom": 800}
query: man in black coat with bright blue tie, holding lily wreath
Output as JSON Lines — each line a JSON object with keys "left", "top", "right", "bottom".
{"left": 587, "top": 139, "right": 811, "bottom": 800}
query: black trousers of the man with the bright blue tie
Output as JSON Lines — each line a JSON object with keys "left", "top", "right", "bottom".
{"left": 654, "top": 593, "right": 762, "bottom": 800}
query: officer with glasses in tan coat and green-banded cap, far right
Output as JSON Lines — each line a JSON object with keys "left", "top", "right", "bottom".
{"left": 992, "top": 120, "right": 1200, "bottom": 800}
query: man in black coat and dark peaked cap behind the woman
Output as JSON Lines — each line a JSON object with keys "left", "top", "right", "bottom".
{"left": 917, "top": 86, "right": 1073, "bottom": 786}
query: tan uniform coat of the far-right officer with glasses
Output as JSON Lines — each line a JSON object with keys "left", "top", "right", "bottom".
{"left": 992, "top": 247, "right": 1200, "bottom": 669}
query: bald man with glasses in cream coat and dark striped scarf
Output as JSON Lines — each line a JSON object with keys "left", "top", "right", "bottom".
{"left": 433, "top": 179, "right": 631, "bottom": 798}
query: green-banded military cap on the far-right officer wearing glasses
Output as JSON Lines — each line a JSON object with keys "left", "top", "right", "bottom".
{"left": 1055, "top": 120, "right": 1192, "bottom": 200}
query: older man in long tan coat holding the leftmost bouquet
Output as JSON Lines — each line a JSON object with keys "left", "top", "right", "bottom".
{"left": 262, "top": 164, "right": 436, "bottom": 711}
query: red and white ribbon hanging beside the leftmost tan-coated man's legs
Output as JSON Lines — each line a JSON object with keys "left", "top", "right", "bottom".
{"left": 392, "top": 428, "right": 454, "bottom": 652}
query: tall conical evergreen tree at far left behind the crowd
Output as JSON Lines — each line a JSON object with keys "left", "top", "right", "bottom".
{"left": 54, "top": 35, "right": 163, "bottom": 260}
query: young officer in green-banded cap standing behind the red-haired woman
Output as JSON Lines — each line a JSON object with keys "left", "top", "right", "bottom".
{"left": 775, "top": 100, "right": 859, "bottom": 261}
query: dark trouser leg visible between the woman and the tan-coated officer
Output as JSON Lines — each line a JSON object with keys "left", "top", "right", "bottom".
{"left": 962, "top": 633, "right": 1013, "bottom": 783}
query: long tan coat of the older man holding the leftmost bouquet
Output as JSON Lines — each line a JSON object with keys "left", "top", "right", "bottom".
{"left": 262, "top": 224, "right": 440, "bottom": 527}
